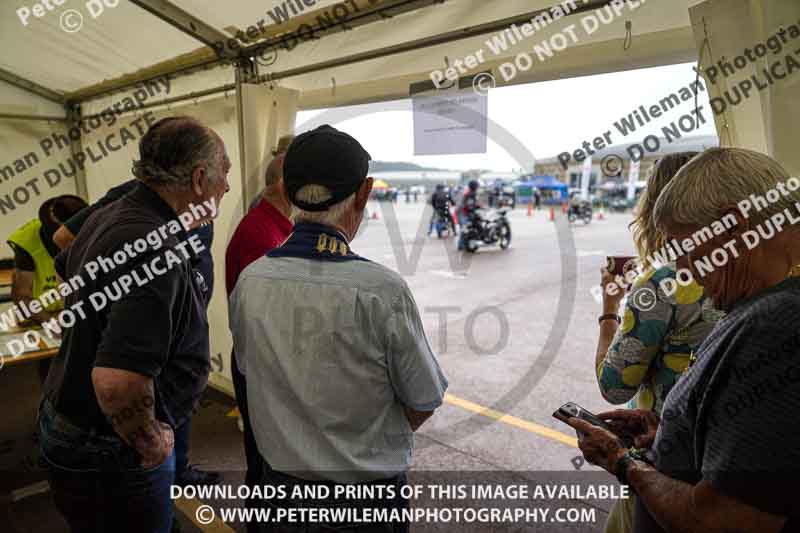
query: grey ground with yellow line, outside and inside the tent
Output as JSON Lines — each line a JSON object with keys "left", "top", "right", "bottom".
{"left": 0, "top": 200, "right": 633, "bottom": 533}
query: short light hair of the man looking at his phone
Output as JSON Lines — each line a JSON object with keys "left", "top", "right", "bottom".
{"left": 653, "top": 148, "right": 800, "bottom": 227}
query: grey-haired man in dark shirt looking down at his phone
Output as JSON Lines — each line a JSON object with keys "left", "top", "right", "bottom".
{"left": 570, "top": 148, "right": 800, "bottom": 533}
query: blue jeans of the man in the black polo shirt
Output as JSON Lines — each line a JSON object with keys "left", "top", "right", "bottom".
{"left": 39, "top": 400, "right": 175, "bottom": 533}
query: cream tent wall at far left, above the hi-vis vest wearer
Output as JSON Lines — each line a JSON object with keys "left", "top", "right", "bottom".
{"left": 0, "top": 81, "right": 77, "bottom": 258}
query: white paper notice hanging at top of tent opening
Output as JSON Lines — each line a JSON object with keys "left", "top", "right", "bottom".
{"left": 412, "top": 90, "right": 489, "bottom": 155}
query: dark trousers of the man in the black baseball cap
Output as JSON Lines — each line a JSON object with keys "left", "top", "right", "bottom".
{"left": 253, "top": 465, "right": 409, "bottom": 533}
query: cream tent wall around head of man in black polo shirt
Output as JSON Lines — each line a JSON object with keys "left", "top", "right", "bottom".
{"left": 85, "top": 95, "right": 243, "bottom": 390}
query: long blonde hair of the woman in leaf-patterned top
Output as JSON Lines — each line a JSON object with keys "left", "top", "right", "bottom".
{"left": 629, "top": 152, "right": 698, "bottom": 269}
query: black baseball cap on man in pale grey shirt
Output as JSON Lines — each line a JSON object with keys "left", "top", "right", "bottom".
{"left": 283, "top": 124, "right": 372, "bottom": 211}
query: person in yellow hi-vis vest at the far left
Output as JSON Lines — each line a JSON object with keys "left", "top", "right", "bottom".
{"left": 7, "top": 195, "right": 86, "bottom": 322}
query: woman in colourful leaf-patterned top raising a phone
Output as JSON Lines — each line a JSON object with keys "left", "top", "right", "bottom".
{"left": 595, "top": 152, "right": 722, "bottom": 533}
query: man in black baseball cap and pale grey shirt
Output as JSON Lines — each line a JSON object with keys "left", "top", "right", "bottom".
{"left": 230, "top": 126, "right": 447, "bottom": 532}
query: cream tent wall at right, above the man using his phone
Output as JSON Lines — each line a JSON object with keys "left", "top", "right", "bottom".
{"left": 691, "top": 0, "right": 800, "bottom": 176}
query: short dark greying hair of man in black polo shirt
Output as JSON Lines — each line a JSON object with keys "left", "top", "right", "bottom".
{"left": 133, "top": 116, "right": 223, "bottom": 185}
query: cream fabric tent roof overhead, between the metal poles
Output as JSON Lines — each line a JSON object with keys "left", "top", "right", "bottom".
{"left": 0, "top": 0, "right": 696, "bottom": 111}
